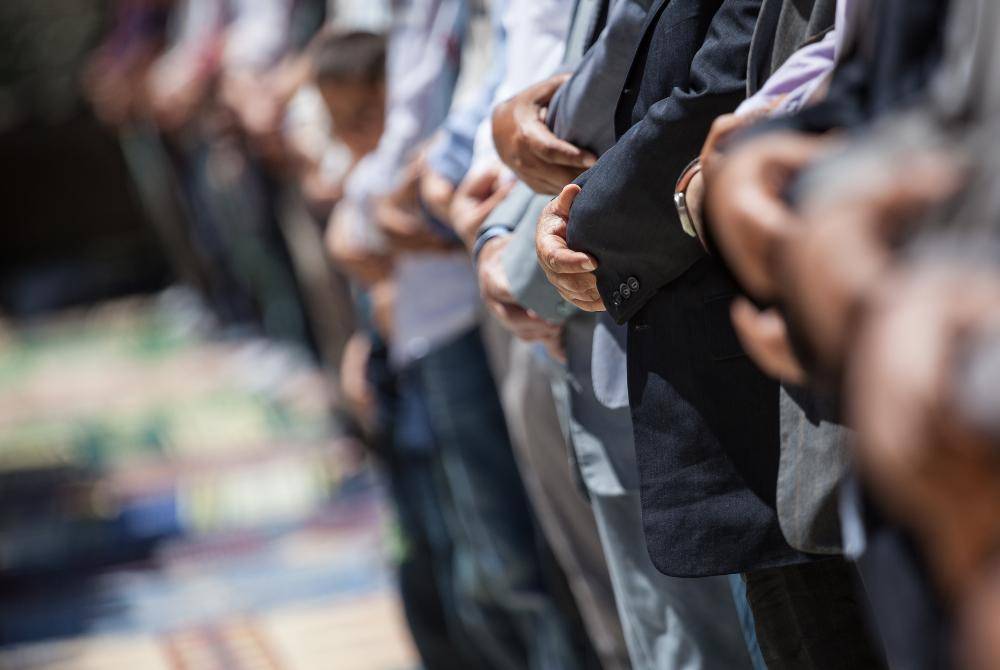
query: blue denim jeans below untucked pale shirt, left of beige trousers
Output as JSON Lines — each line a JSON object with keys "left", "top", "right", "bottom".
{"left": 414, "top": 329, "right": 583, "bottom": 670}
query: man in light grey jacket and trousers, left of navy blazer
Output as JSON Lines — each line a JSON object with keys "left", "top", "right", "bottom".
{"left": 474, "top": 0, "right": 750, "bottom": 669}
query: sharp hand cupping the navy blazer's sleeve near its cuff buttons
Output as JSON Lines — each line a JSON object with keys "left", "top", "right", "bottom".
{"left": 535, "top": 184, "right": 605, "bottom": 312}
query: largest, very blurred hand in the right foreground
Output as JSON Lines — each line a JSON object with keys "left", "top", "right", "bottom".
{"left": 845, "top": 265, "right": 1000, "bottom": 594}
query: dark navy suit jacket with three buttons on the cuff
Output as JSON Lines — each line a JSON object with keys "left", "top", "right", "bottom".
{"left": 569, "top": 0, "right": 805, "bottom": 576}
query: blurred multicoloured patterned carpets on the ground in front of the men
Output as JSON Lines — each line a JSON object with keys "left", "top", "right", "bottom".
{"left": 0, "top": 292, "right": 416, "bottom": 670}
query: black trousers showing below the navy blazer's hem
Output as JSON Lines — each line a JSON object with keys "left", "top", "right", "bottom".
{"left": 743, "top": 558, "right": 886, "bottom": 670}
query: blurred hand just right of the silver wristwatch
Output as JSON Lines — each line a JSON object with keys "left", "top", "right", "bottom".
{"left": 703, "top": 133, "right": 825, "bottom": 300}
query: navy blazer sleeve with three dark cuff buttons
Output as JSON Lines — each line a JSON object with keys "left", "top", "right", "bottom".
{"left": 568, "top": 0, "right": 761, "bottom": 323}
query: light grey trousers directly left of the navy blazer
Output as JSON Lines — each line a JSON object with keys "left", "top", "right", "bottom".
{"left": 553, "top": 318, "right": 752, "bottom": 670}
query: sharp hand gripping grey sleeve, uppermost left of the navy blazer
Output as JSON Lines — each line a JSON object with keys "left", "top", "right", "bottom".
{"left": 493, "top": 74, "right": 597, "bottom": 194}
